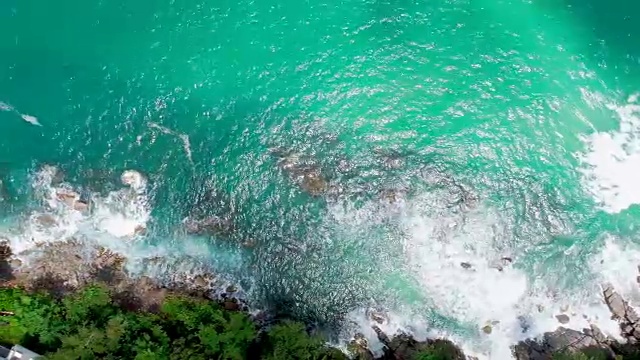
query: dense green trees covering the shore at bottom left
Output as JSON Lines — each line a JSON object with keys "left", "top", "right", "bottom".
{"left": 0, "top": 285, "right": 346, "bottom": 360}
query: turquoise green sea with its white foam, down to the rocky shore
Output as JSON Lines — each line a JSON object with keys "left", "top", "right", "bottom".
{"left": 0, "top": 0, "right": 640, "bottom": 359}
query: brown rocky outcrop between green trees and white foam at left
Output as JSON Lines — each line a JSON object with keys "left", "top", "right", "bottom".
{"left": 0, "top": 239, "right": 246, "bottom": 311}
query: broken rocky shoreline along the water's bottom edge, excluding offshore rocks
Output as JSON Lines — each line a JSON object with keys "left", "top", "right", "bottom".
{"left": 0, "top": 239, "right": 640, "bottom": 360}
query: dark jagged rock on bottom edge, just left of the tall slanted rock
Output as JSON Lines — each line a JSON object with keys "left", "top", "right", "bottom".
{"left": 513, "top": 327, "right": 613, "bottom": 360}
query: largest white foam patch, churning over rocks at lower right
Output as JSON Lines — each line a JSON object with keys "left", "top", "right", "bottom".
{"left": 332, "top": 194, "right": 640, "bottom": 360}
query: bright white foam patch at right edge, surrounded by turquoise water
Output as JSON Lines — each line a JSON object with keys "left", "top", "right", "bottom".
{"left": 582, "top": 95, "right": 640, "bottom": 213}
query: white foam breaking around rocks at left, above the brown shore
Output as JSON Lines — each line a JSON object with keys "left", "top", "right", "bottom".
{"left": 0, "top": 165, "right": 246, "bottom": 298}
